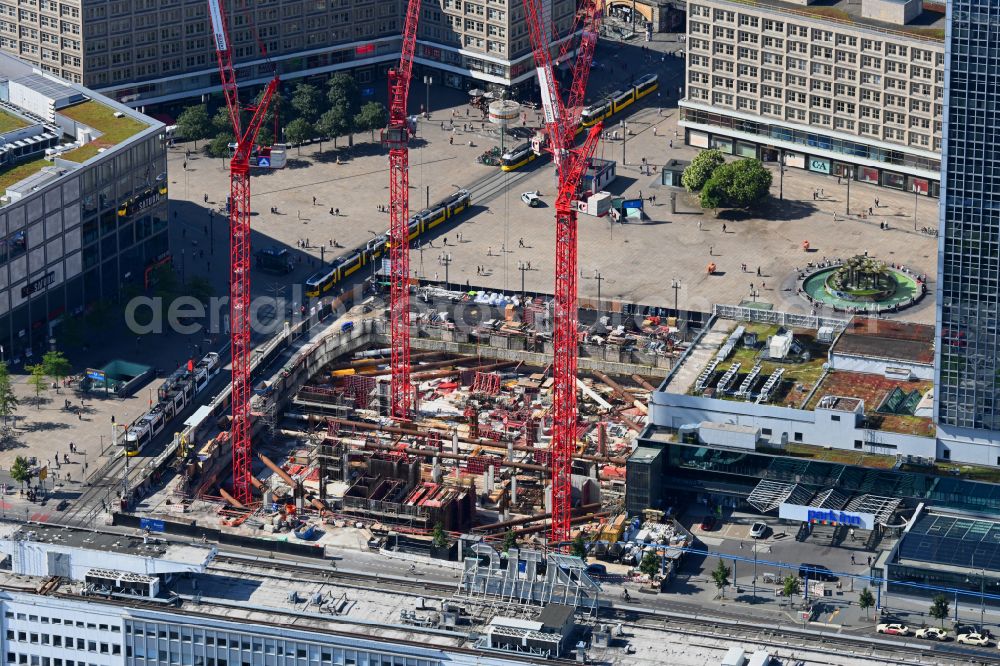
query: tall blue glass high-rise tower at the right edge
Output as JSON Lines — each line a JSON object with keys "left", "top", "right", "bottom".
{"left": 935, "top": 0, "right": 1000, "bottom": 454}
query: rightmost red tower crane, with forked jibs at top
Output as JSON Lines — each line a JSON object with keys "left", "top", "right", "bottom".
{"left": 524, "top": 0, "right": 603, "bottom": 544}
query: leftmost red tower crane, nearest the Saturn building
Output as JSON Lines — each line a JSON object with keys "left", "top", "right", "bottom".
{"left": 208, "top": 0, "right": 278, "bottom": 505}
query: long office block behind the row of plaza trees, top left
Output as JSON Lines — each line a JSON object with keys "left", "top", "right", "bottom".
{"left": 0, "top": 0, "right": 575, "bottom": 107}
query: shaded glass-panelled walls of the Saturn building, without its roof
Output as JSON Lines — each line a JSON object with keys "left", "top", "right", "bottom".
{"left": 0, "top": 133, "right": 169, "bottom": 362}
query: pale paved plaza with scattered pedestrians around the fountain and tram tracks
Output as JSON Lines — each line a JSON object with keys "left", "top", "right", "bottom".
{"left": 170, "top": 36, "right": 938, "bottom": 322}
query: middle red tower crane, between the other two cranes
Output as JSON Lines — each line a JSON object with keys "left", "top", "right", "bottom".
{"left": 382, "top": 0, "right": 420, "bottom": 419}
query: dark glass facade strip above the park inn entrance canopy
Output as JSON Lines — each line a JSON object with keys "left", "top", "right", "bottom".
{"left": 629, "top": 444, "right": 1000, "bottom": 512}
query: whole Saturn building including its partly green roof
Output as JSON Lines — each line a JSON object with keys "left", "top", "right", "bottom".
{"left": 0, "top": 55, "right": 170, "bottom": 363}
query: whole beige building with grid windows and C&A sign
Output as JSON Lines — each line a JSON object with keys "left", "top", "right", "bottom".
{"left": 680, "top": 0, "right": 944, "bottom": 196}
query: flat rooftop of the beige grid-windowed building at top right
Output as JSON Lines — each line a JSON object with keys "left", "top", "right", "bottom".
{"left": 725, "top": 0, "right": 946, "bottom": 42}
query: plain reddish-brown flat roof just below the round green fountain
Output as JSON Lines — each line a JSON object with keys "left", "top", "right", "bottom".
{"left": 832, "top": 317, "right": 934, "bottom": 365}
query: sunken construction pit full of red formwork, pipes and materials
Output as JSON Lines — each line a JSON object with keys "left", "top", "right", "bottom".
{"left": 141, "top": 293, "right": 685, "bottom": 549}
